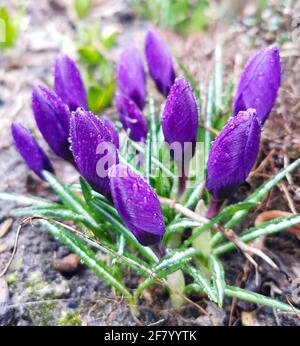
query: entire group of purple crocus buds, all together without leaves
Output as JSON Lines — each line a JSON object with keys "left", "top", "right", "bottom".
{"left": 12, "top": 30, "right": 281, "bottom": 245}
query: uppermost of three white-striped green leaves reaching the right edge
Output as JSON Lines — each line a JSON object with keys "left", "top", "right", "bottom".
{"left": 212, "top": 158, "right": 300, "bottom": 246}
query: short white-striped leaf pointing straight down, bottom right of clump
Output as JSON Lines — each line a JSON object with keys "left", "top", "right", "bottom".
{"left": 209, "top": 255, "right": 226, "bottom": 308}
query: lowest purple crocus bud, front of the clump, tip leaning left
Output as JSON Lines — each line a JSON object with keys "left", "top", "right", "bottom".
{"left": 109, "top": 164, "right": 165, "bottom": 245}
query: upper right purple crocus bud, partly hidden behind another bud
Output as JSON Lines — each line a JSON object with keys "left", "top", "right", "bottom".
{"left": 233, "top": 45, "right": 281, "bottom": 124}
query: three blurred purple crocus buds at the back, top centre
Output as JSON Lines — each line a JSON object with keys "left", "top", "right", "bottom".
{"left": 116, "top": 29, "right": 175, "bottom": 142}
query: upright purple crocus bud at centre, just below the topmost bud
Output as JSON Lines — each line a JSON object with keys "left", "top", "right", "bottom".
{"left": 161, "top": 77, "right": 198, "bottom": 160}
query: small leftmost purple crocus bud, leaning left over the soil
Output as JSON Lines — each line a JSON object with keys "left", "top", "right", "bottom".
{"left": 11, "top": 122, "right": 54, "bottom": 179}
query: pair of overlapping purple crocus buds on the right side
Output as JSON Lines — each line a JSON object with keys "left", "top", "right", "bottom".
{"left": 206, "top": 45, "right": 281, "bottom": 200}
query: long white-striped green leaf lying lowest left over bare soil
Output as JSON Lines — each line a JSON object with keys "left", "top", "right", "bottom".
{"left": 39, "top": 220, "right": 131, "bottom": 299}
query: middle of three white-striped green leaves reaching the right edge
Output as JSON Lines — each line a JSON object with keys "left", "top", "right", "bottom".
{"left": 213, "top": 214, "right": 300, "bottom": 256}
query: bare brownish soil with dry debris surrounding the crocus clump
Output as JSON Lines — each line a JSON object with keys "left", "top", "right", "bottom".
{"left": 0, "top": 0, "right": 300, "bottom": 325}
